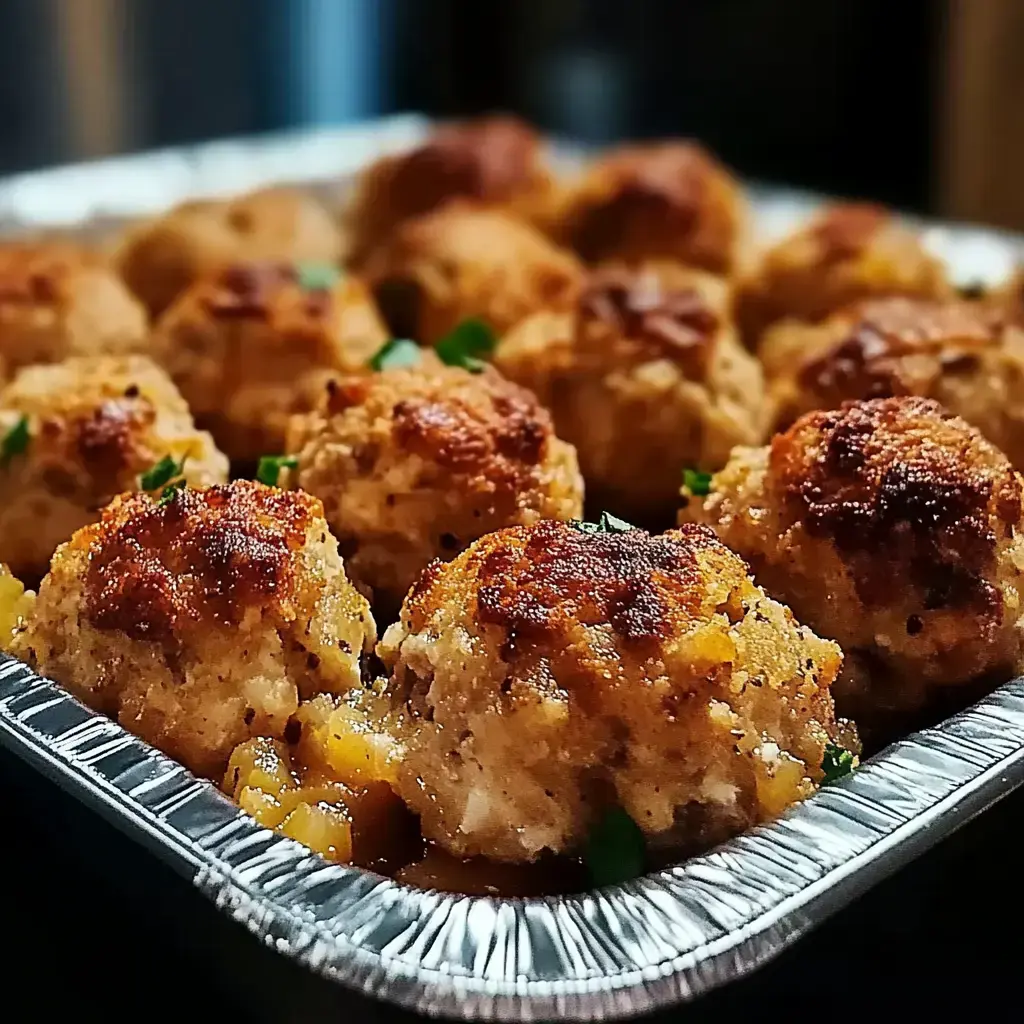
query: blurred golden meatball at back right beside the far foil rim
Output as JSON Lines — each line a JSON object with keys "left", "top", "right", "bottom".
{"left": 735, "top": 203, "right": 952, "bottom": 348}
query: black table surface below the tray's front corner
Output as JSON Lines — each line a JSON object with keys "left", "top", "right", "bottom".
{"left": 6, "top": 737, "right": 1024, "bottom": 1024}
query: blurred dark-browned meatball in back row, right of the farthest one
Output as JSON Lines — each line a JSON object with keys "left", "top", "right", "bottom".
{"left": 555, "top": 141, "right": 750, "bottom": 274}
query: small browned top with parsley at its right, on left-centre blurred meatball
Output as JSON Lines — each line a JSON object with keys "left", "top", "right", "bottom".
{"left": 201, "top": 261, "right": 333, "bottom": 319}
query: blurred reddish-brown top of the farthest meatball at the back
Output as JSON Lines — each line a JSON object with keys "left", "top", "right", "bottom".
{"left": 393, "top": 118, "right": 538, "bottom": 216}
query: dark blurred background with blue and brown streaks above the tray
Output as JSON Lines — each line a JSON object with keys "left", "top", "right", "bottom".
{"left": 0, "top": 0, "right": 1024, "bottom": 223}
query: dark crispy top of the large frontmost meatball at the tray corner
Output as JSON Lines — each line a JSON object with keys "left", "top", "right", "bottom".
{"left": 407, "top": 520, "right": 733, "bottom": 653}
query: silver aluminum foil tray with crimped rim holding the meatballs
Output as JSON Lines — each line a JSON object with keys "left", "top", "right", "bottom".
{"left": 0, "top": 118, "right": 1024, "bottom": 1021}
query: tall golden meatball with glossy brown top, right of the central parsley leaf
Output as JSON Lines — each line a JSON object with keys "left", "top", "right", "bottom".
{"left": 495, "top": 260, "right": 764, "bottom": 526}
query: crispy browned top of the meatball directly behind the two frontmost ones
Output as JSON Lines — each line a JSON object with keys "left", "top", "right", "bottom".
{"left": 327, "top": 361, "right": 553, "bottom": 489}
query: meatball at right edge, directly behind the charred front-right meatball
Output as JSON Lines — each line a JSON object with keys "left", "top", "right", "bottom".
{"left": 762, "top": 298, "right": 1024, "bottom": 466}
